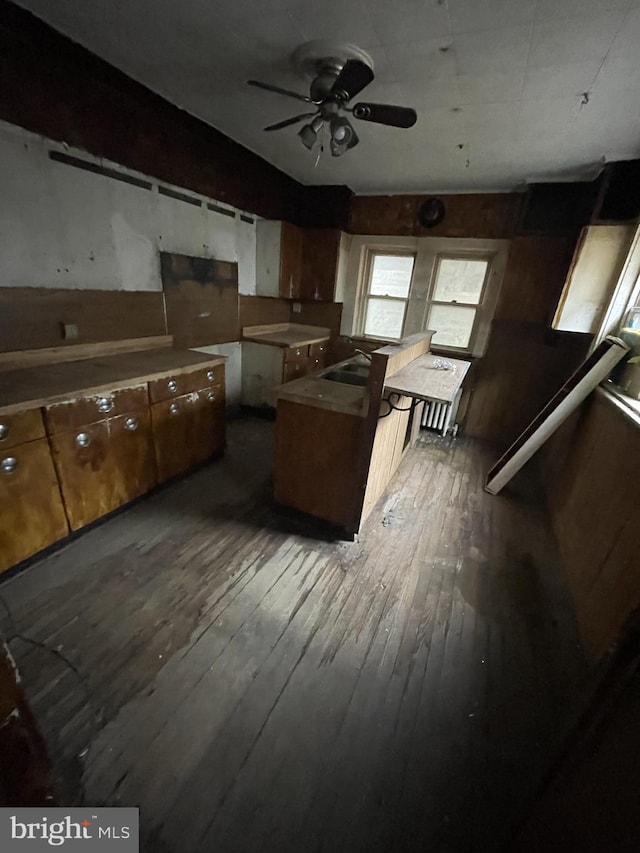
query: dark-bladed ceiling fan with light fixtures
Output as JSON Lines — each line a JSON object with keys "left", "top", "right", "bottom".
{"left": 247, "top": 42, "right": 418, "bottom": 157}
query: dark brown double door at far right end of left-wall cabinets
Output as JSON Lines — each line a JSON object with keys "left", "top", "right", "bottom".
{"left": 151, "top": 386, "right": 225, "bottom": 482}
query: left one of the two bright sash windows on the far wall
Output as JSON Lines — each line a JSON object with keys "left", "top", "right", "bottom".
{"left": 363, "top": 252, "right": 415, "bottom": 340}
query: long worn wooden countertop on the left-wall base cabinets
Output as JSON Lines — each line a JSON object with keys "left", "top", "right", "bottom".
{"left": 0, "top": 347, "right": 226, "bottom": 414}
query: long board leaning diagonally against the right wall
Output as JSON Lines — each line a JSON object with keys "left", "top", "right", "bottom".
{"left": 485, "top": 337, "right": 629, "bottom": 495}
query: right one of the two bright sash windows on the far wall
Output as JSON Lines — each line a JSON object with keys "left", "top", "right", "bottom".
{"left": 426, "top": 255, "right": 489, "bottom": 350}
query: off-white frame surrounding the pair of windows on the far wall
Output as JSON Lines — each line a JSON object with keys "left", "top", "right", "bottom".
{"left": 341, "top": 235, "right": 509, "bottom": 357}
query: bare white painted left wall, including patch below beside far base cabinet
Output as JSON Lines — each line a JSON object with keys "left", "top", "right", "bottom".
{"left": 0, "top": 117, "right": 256, "bottom": 403}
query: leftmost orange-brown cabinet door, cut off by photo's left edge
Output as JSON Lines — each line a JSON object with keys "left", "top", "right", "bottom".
{"left": 0, "top": 439, "right": 69, "bottom": 571}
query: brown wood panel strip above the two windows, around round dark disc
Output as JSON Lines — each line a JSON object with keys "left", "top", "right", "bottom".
{"left": 348, "top": 193, "right": 522, "bottom": 239}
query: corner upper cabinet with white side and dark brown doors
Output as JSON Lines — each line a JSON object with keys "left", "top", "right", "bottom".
{"left": 256, "top": 219, "right": 344, "bottom": 302}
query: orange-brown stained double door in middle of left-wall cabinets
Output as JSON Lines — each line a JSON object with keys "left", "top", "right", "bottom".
{"left": 51, "top": 410, "right": 156, "bottom": 530}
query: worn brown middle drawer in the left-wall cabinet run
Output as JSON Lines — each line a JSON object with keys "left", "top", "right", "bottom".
{"left": 45, "top": 382, "right": 149, "bottom": 435}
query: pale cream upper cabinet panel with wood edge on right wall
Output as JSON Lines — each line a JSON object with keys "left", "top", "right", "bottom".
{"left": 553, "top": 223, "right": 636, "bottom": 334}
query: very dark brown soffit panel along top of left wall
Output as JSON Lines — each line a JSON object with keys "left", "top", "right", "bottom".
{"left": 0, "top": 0, "right": 301, "bottom": 219}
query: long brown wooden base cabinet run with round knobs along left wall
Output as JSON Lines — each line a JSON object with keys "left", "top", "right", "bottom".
{"left": 0, "top": 364, "right": 225, "bottom": 572}
